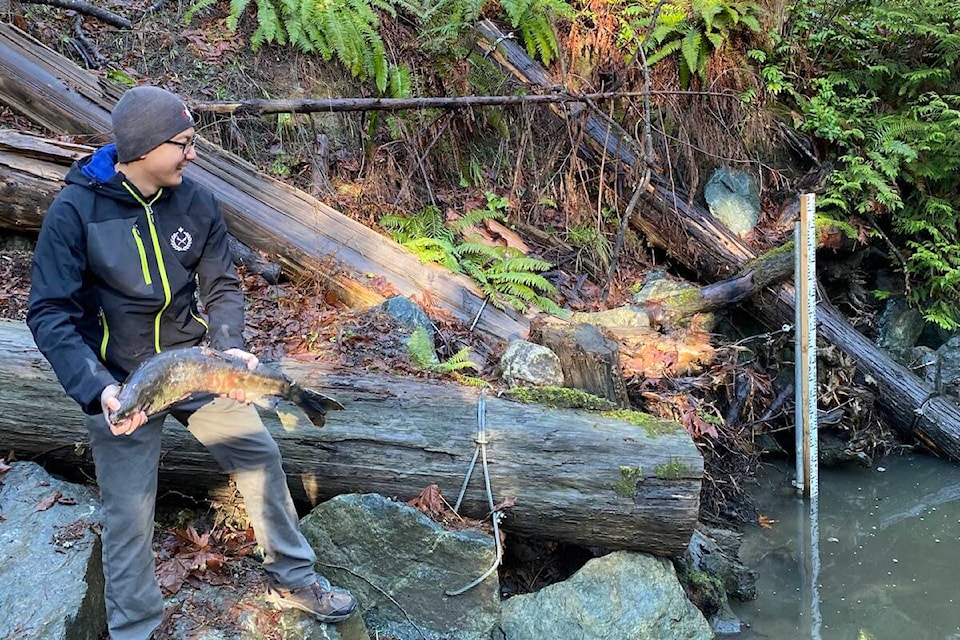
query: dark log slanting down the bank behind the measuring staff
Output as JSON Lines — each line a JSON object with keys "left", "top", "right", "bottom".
{"left": 478, "top": 20, "right": 960, "bottom": 460}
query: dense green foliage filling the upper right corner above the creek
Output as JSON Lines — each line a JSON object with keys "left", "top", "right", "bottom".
{"left": 751, "top": 0, "right": 960, "bottom": 329}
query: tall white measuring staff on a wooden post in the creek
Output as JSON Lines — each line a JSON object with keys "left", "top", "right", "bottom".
{"left": 794, "top": 193, "right": 819, "bottom": 497}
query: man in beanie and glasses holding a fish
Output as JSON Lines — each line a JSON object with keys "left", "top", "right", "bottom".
{"left": 27, "top": 86, "right": 356, "bottom": 640}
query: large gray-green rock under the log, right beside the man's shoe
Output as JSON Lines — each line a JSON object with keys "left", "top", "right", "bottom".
{"left": 300, "top": 494, "right": 500, "bottom": 640}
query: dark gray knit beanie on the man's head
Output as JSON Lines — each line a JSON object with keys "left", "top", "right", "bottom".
{"left": 110, "top": 87, "right": 196, "bottom": 162}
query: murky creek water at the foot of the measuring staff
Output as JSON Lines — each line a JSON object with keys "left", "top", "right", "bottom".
{"left": 732, "top": 454, "right": 960, "bottom": 640}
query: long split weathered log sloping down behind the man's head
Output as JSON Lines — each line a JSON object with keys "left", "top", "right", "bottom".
{"left": 0, "top": 24, "right": 527, "bottom": 350}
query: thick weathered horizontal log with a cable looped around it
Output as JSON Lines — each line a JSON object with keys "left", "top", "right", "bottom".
{"left": 0, "top": 320, "right": 703, "bottom": 556}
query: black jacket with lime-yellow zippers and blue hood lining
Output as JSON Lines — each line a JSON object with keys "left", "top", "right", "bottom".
{"left": 27, "top": 145, "right": 243, "bottom": 414}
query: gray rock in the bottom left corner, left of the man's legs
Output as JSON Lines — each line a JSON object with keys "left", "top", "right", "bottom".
{"left": 0, "top": 462, "right": 106, "bottom": 640}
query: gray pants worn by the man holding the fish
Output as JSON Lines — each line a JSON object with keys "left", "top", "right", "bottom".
{"left": 87, "top": 398, "right": 316, "bottom": 640}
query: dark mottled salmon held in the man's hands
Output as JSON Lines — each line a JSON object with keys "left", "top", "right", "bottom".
{"left": 109, "top": 347, "right": 343, "bottom": 427}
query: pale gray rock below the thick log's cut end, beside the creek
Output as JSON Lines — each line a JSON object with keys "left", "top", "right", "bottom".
{"left": 500, "top": 551, "right": 714, "bottom": 640}
